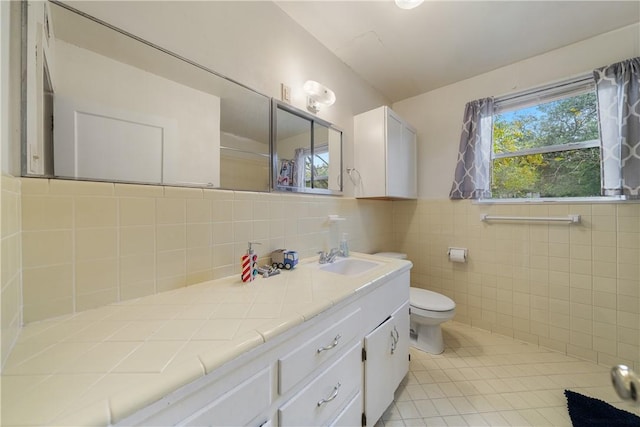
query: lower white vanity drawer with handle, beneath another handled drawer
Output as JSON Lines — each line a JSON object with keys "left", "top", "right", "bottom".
{"left": 278, "top": 341, "right": 362, "bottom": 426}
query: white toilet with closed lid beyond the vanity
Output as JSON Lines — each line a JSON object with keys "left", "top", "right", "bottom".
{"left": 375, "top": 252, "right": 456, "bottom": 354}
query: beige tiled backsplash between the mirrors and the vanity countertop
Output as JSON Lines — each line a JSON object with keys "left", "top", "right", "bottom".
{"left": 22, "top": 178, "right": 392, "bottom": 323}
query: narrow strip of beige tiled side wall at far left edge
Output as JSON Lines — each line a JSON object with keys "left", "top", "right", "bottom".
{"left": 0, "top": 176, "right": 22, "bottom": 366}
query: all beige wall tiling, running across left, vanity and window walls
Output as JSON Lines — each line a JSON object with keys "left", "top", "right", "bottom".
{"left": 17, "top": 178, "right": 640, "bottom": 369}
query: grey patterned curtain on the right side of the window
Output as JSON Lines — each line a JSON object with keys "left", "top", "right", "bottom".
{"left": 593, "top": 57, "right": 640, "bottom": 199}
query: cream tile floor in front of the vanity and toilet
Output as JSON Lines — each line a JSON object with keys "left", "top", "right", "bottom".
{"left": 376, "top": 322, "right": 640, "bottom": 427}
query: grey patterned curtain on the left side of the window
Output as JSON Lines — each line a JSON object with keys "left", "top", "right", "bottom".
{"left": 449, "top": 98, "right": 493, "bottom": 199}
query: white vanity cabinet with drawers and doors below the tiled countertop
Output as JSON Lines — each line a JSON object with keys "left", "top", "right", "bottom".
{"left": 116, "top": 269, "right": 409, "bottom": 427}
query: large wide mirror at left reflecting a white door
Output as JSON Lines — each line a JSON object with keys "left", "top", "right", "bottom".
{"left": 22, "top": 2, "right": 271, "bottom": 191}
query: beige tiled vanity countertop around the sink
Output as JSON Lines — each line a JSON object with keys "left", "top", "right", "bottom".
{"left": 1, "top": 253, "right": 411, "bottom": 426}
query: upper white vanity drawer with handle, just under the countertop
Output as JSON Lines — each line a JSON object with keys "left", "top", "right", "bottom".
{"left": 278, "top": 309, "right": 362, "bottom": 394}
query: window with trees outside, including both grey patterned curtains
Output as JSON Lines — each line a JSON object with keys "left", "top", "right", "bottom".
{"left": 449, "top": 57, "right": 640, "bottom": 200}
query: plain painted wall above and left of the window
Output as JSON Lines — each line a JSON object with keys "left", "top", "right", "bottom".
{"left": 393, "top": 24, "right": 640, "bottom": 199}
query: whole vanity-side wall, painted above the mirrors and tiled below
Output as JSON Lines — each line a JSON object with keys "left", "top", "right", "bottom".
{"left": 13, "top": 1, "right": 392, "bottom": 327}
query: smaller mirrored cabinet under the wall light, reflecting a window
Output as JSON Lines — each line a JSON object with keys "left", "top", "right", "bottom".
{"left": 272, "top": 100, "right": 342, "bottom": 194}
